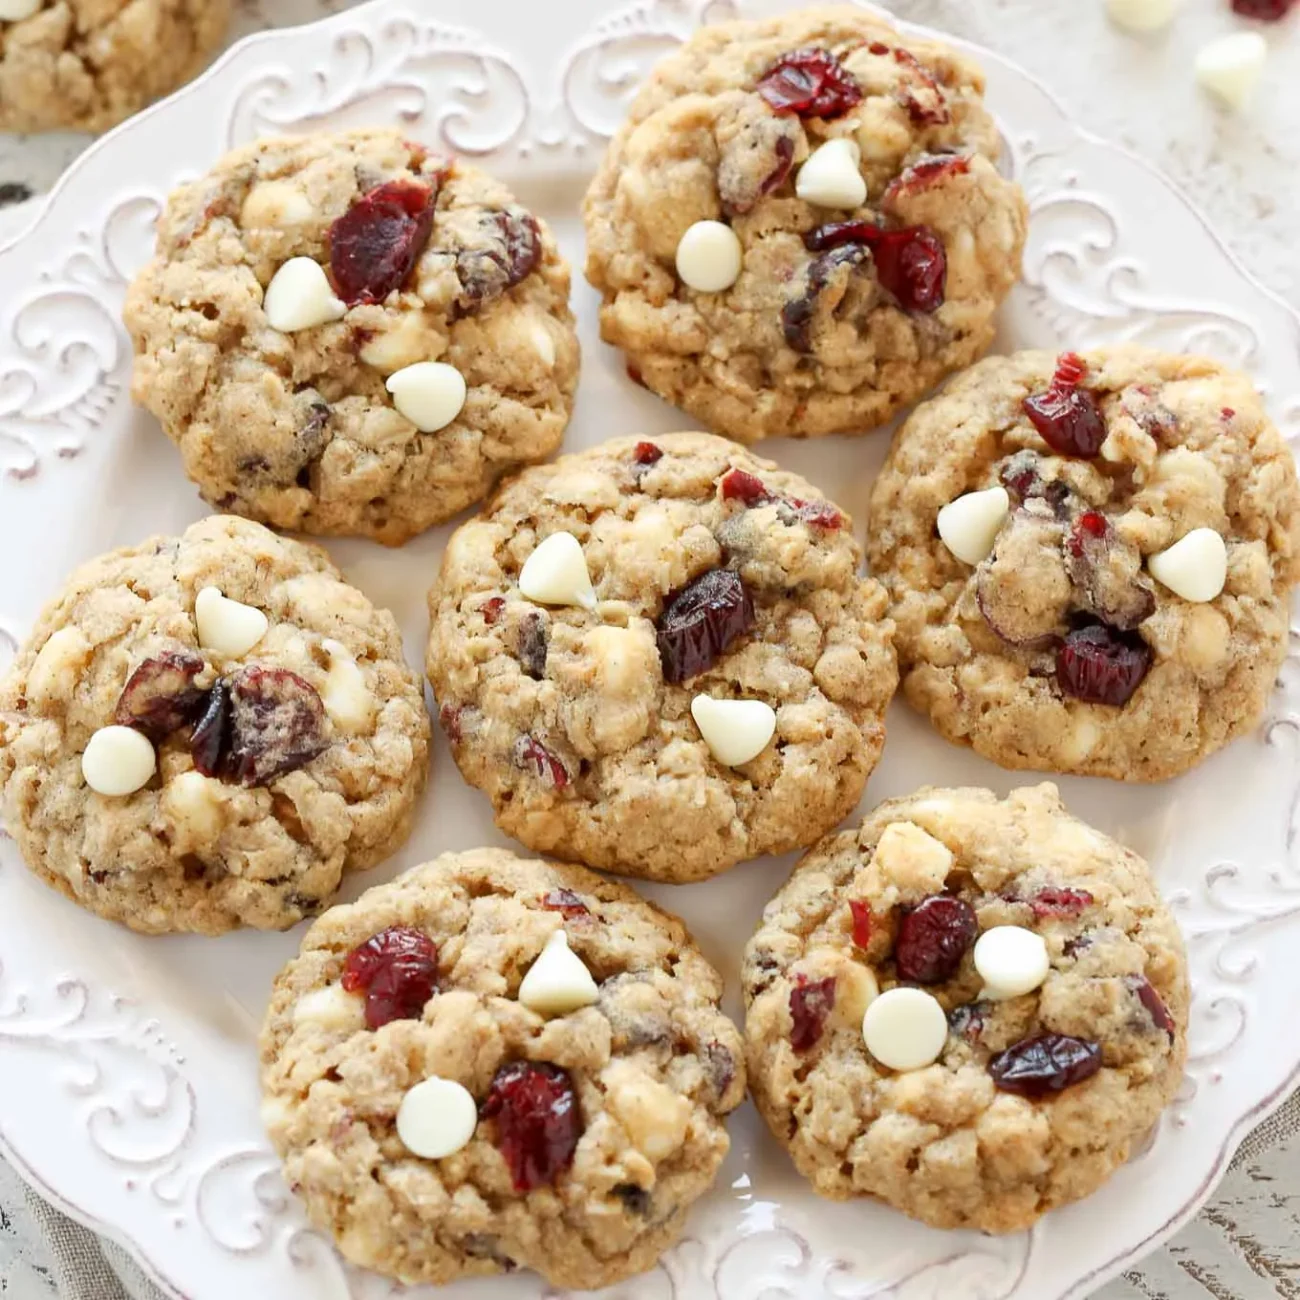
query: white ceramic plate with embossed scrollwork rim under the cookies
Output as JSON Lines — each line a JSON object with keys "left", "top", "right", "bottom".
{"left": 0, "top": 0, "right": 1300, "bottom": 1300}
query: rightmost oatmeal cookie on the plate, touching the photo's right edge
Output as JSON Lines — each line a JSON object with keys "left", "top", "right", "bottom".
{"left": 867, "top": 347, "right": 1300, "bottom": 781}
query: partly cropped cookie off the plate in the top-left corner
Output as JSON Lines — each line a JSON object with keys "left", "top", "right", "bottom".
{"left": 0, "top": 0, "right": 231, "bottom": 131}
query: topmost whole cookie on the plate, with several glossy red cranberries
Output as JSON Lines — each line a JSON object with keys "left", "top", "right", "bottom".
{"left": 584, "top": 7, "right": 1027, "bottom": 442}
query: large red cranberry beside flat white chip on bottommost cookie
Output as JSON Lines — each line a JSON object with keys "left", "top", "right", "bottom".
{"left": 480, "top": 1061, "right": 582, "bottom": 1192}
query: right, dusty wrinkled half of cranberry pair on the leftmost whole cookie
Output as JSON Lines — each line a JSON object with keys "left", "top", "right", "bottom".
{"left": 224, "top": 664, "right": 329, "bottom": 785}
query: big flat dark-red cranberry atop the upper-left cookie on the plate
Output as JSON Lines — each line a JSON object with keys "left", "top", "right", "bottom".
{"left": 329, "top": 181, "right": 438, "bottom": 306}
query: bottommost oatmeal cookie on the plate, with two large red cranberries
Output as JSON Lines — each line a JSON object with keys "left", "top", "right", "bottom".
{"left": 261, "top": 849, "right": 745, "bottom": 1288}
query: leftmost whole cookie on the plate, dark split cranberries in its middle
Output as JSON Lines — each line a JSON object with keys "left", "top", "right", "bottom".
{"left": 0, "top": 517, "right": 429, "bottom": 935}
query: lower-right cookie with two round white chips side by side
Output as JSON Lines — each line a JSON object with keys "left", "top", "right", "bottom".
{"left": 742, "top": 785, "right": 1190, "bottom": 1232}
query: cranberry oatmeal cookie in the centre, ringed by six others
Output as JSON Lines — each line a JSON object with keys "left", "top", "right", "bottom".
{"left": 428, "top": 433, "right": 898, "bottom": 881}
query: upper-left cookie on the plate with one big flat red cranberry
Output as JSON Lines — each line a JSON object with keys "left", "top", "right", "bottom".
{"left": 125, "top": 131, "right": 579, "bottom": 546}
